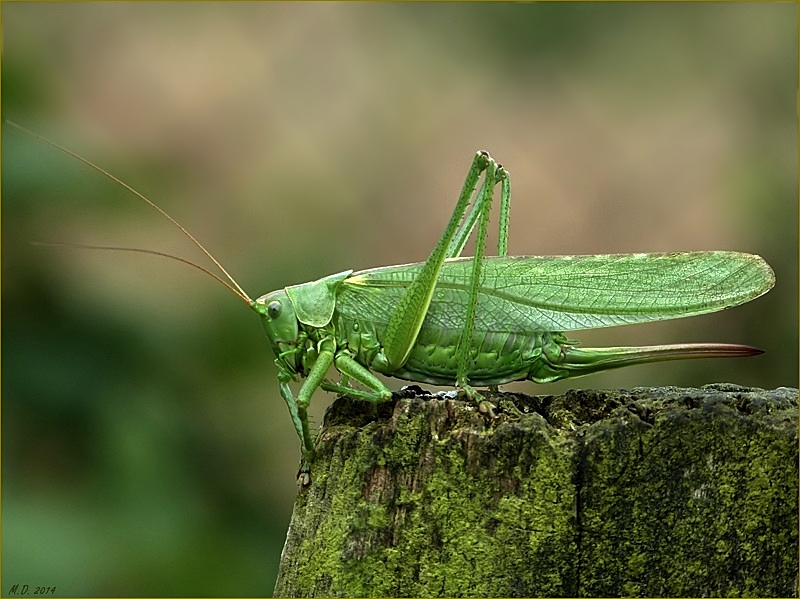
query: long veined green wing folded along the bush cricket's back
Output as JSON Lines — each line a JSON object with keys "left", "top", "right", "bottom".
{"left": 337, "top": 251, "right": 775, "bottom": 332}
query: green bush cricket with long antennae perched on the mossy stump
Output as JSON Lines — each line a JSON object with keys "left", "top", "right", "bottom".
{"left": 10, "top": 123, "right": 775, "bottom": 484}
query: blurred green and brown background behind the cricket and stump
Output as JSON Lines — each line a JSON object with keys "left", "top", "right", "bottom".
{"left": 2, "top": 3, "right": 798, "bottom": 596}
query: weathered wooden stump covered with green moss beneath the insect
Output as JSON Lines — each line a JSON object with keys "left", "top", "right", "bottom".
{"left": 275, "top": 384, "right": 798, "bottom": 597}
